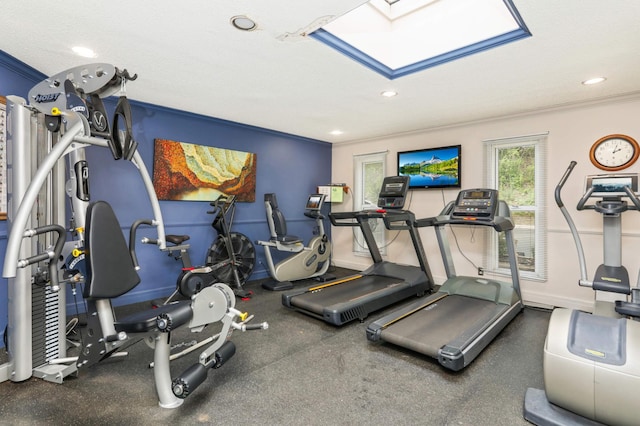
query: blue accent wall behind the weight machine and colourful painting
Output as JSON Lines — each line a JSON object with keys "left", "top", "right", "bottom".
{"left": 0, "top": 51, "right": 331, "bottom": 346}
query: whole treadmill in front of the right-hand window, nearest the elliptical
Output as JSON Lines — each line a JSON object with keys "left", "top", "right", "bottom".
{"left": 366, "top": 189, "right": 523, "bottom": 371}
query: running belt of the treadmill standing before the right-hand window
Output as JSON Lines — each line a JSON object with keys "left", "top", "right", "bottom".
{"left": 380, "top": 295, "right": 508, "bottom": 358}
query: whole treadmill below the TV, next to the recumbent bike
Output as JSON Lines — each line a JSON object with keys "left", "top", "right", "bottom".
{"left": 282, "top": 176, "right": 433, "bottom": 326}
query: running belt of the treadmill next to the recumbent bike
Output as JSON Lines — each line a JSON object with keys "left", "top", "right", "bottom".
{"left": 291, "top": 275, "right": 404, "bottom": 315}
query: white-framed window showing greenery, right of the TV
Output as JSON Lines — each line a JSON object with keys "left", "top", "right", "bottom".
{"left": 484, "top": 133, "right": 547, "bottom": 280}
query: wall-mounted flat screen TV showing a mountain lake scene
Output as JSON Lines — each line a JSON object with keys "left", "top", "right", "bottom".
{"left": 398, "top": 145, "right": 462, "bottom": 189}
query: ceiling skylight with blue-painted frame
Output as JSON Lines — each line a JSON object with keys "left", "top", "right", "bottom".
{"left": 310, "top": 0, "right": 531, "bottom": 79}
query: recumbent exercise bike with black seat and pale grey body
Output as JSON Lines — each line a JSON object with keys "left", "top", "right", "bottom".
{"left": 256, "top": 194, "right": 335, "bottom": 291}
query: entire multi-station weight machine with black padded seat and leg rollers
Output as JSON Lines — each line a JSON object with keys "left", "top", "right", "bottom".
{"left": 0, "top": 64, "right": 268, "bottom": 408}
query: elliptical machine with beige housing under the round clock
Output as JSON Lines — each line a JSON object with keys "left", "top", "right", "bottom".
{"left": 524, "top": 161, "right": 640, "bottom": 425}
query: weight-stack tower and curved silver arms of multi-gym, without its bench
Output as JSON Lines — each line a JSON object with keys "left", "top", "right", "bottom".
{"left": 0, "top": 64, "right": 145, "bottom": 383}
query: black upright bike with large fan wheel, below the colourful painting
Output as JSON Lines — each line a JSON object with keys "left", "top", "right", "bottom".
{"left": 129, "top": 195, "right": 256, "bottom": 305}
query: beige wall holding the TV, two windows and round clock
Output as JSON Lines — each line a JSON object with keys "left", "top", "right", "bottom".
{"left": 332, "top": 96, "right": 640, "bottom": 309}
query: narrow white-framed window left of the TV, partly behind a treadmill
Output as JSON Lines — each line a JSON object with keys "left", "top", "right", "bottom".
{"left": 353, "top": 151, "right": 387, "bottom": 256}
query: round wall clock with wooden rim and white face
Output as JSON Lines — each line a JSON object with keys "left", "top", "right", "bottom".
{"left": 589, "top": 134, "right": 640, "bottom": 172}
